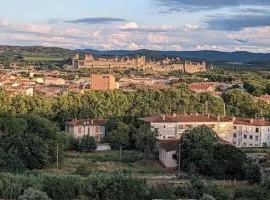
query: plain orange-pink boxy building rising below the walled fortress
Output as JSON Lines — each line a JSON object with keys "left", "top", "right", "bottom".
{"left": 90, "top": 74, "right": 117, "bottom": 90}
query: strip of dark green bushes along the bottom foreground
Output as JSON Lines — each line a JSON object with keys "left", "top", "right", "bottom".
{"left": 0, "top": 173, "right": 270, "bottom": 200}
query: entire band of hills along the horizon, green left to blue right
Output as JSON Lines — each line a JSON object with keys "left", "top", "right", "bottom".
{"left": 0, "top": 45, "right": 270, "bottom": 65}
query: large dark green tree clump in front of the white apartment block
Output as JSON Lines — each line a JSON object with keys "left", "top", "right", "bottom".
{"left": 180, "top": 126, "right": 261, "bottom": 183}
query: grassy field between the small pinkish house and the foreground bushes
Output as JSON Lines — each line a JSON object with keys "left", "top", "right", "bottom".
{"left": 43, "top": 151, "right": 166, "bottom": 174}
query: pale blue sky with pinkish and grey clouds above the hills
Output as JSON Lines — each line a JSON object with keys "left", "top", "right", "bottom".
{"left": 0, "top": 0, "right": 270, "bottom": 53}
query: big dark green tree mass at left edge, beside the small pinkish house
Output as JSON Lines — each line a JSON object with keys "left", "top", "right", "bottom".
{"left": 0, "top": 115, "right": 62, "bottom": 171}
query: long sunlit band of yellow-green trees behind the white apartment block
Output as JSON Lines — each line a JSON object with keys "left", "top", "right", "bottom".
{"left": 0, "top": 88, "right": 226, "bottom": 127}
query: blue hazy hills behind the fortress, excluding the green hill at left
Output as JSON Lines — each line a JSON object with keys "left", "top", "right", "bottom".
{"left": 75, "top": 49, "right": 270, "bottom": 63}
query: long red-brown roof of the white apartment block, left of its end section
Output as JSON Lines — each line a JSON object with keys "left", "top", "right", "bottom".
{"left": 140, "top": 114, "right": 232, "bottom": 123}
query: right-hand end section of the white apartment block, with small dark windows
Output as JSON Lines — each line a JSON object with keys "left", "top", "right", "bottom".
{"left": 231, "top": 117, "right": 270, "bottom": 147}
